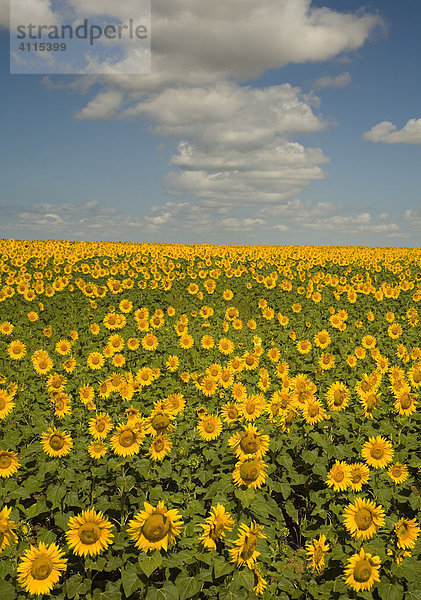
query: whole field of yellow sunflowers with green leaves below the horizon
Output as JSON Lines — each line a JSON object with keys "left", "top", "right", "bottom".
{"left": 0, "top": 239, "right": 421, "bottom": 600}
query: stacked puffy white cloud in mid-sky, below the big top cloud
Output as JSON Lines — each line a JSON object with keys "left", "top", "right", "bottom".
{"left": 122, "top": 82, "right": 329, "bottom": 206}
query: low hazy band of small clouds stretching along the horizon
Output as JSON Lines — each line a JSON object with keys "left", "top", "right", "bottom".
{"left": 0, "top": 198, "right": 414, "bottom": 245}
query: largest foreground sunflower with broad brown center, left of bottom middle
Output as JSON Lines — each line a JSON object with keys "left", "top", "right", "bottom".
{"left": 127, "top": 501, "right": 184, "bottom": 552}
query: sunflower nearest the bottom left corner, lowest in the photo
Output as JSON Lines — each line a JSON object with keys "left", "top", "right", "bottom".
{"left": 17, "top": 542, "right": 67, "bottom": 595}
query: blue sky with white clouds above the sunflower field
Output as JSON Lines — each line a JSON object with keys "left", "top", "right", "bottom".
{"left": 0, "top": 0, "right": 421, "bottom": 247}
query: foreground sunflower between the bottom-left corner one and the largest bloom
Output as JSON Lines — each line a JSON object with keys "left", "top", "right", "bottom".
{"left": 65, "top": 509, "right": 114, "bottom": 556}
